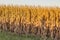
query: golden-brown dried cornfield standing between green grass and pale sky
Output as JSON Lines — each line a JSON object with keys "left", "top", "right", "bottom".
{"left": 0, "top": 6, "right": 60, "bottom": 40}
